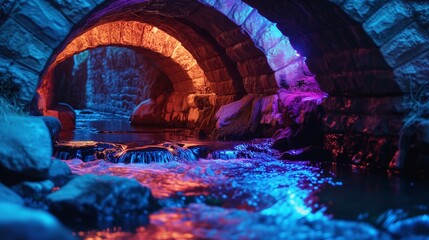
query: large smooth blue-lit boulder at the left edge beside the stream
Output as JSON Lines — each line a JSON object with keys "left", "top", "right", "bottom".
{"left": 0, "top": 115, "right": 52, "bottom": 182}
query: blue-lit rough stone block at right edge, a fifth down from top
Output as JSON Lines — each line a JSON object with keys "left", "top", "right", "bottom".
{"left": 380, "top": 24, "right": 429, "bottom": 67}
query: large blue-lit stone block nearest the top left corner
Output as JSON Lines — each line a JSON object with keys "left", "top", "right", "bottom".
{"left": 9, "top": 0, "right": 71, "bottom": 48}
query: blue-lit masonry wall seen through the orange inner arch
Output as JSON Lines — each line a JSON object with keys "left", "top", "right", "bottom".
{"left": 54, "top": 47, "right": 172, "bottom": 116}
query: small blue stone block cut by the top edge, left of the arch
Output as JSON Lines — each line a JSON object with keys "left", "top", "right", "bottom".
{"left": 52, "top": 0, "right": 95, "bottom": 23}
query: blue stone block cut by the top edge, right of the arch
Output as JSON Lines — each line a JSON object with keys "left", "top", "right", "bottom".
{"left": 341, "top": 0, "right": 385, "bottom": 22}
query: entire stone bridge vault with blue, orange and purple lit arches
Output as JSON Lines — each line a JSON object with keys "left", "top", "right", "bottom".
{"left": 0, "top": 0, "right": 429, "bottom": 165}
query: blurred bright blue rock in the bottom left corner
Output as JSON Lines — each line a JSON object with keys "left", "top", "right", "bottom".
{"left": 0, "top": 202, "right": 74, "bottom": 240}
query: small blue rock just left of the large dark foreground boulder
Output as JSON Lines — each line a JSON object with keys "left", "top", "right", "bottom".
{"left": 12, "top": 180, "right": 54, "bottom": 198}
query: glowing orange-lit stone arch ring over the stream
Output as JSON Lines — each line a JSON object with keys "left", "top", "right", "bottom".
{"left": 39, "top": 21, "right": 211, "bottom": 105}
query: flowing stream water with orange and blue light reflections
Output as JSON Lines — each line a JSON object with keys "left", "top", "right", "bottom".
{"left": 57, "top": 111, "right": 429, "bottom": 239}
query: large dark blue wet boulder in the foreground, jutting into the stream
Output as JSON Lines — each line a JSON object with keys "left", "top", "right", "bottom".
{"left": 47, "top": 174, "right": 158, "bottom": 227}
